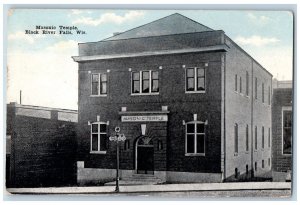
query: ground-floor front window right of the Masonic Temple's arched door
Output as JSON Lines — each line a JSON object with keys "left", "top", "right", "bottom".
{"left": 186, "top": 122, "right": 205, "bottom": 155}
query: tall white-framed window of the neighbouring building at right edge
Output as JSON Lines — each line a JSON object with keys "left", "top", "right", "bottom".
{"left": 282, "top": 110, "right": 292, "bottom": 154}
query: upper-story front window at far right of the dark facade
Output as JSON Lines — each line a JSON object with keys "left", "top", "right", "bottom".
{"left": 186, "top": 67, "right": 205, "bottom": 92}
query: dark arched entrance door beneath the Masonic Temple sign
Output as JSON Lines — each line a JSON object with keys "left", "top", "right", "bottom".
{"left": 136, "top": 137, "right": 154, "bottom": 174}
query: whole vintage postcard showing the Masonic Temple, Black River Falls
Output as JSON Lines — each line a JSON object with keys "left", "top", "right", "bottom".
{"left": 5, "top": 8, "right": 295, "bottom": 198}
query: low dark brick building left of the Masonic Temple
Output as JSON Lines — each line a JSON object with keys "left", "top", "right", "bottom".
{"left": 6, "top": 103, "right": 78, "bottom": 187}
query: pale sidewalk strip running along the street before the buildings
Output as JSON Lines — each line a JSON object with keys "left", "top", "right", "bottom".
{"left": 7, "top": 182, "right": 291, "bottom": 194}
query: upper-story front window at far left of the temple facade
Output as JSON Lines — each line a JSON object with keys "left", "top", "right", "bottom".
{"left": 91, "top": 73, "right": 107, "bottom": 96}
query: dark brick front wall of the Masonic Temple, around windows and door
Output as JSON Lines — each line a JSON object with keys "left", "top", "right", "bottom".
{"left": 78, "top": 50, "right": 221, "bottom": 173}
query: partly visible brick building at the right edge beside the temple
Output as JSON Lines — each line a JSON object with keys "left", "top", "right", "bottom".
{"left": 272, "top": 81, "right": 293, "bottom": 181}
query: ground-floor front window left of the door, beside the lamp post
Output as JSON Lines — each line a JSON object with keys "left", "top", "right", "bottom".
{"left": 91, "top": 122, "right": 107, "bottom": 153}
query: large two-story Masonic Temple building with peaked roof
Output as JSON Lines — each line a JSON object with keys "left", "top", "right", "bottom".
{"left": 73, "top": 14, "right": 272, "bottom": 183}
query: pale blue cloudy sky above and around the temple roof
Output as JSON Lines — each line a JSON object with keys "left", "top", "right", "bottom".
{"left": 7, "top": 9, "right": 293, "bottom": 109}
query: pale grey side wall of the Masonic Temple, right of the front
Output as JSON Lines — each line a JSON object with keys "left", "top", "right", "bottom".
{"left": 224, "top": 39, "right": 272, "bottom": 178}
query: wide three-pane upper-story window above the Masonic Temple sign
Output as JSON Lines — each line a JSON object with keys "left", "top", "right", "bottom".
{"left": 132, "top": 70, "right": 159, "bottom": 94}
